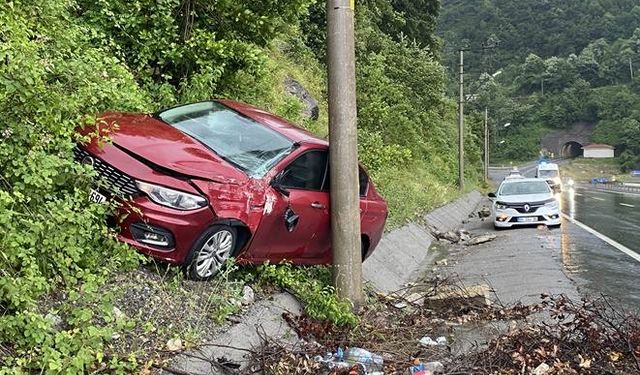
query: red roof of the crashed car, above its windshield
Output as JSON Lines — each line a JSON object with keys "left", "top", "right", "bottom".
{"left": 220, "top": 99, "right": 329, "bottom": 148}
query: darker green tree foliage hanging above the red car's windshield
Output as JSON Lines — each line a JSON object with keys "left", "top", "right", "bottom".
{"left": 78, "top": 0, "right": 310, "bottom": 106}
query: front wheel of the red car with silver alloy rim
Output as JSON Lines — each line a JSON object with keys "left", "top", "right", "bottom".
{"left": 183, "top": 225, "right": 238, "bottom": 280}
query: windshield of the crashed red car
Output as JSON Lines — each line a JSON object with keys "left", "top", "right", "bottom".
{"left": 156, "top": 102, "right": 295, "bottom": 177}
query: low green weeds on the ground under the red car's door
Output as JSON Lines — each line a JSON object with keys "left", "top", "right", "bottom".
{"left": 258, "top": 263, "right": 358, "bottom": 326}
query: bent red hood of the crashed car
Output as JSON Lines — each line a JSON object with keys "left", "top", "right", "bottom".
{"left": 83, "top": 113, "right": 248, "bottom": 183}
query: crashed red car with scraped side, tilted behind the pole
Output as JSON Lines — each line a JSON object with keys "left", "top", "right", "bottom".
{"left": 75, "top": 100, "right": 387, "bottom": 279}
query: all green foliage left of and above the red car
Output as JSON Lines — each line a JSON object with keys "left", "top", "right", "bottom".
{"left": 0, "top": 1, "right": 318, "bottom": 374}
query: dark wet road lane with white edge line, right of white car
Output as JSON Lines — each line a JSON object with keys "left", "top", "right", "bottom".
{"left": 560, "top": 188, "right": 640, "bottom": 310}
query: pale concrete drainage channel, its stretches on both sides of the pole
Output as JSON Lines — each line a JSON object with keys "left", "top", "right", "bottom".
{"left": 163, "top": 191, "right": 482, "bottom": 375}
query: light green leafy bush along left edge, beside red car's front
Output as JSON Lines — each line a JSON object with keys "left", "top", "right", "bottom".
{"left": 0, "top": 1, "right": 149, "bottom": 373}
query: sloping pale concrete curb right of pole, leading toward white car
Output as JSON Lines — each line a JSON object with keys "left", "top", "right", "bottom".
{"left": 362, "top": 191, "right": 482, "bottom": 293}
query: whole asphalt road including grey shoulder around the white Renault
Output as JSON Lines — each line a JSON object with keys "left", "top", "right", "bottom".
{"left": 450, "top": 165, "right": 640, "bottom": 311}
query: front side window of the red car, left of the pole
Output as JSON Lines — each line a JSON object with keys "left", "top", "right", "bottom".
{"left": 281, "top": 151, "right": 328, "bottom": 190}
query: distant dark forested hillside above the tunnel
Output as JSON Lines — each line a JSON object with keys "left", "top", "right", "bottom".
{"left": 439, "top": 0, "right": 640, "bottom": 168}
